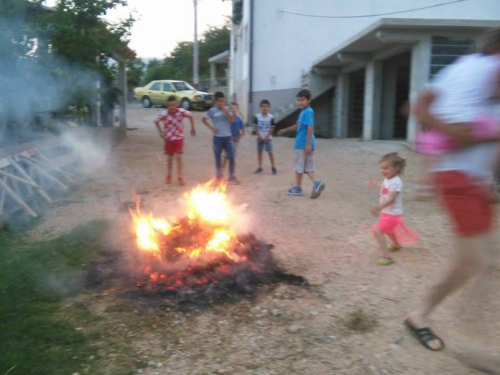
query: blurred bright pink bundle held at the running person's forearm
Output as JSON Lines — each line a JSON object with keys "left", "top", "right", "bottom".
{"left": 415, "top": 116, "right": 500, "bottom": 155}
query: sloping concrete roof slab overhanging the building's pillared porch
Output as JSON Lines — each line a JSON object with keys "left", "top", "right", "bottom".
{"left": 312, "top": 18, "right": 500, "bottom": 74}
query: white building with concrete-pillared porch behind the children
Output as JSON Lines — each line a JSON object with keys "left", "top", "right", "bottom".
{"left": 229, "top": 0, "right": 500, "bottom": 141}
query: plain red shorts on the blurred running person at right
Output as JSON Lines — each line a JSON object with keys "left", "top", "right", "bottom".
{"left": 433, "top": 171, "right": 494, "bottom": 237}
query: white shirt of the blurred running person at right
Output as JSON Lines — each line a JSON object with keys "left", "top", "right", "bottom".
{"left": 429, "top": 53, "right": 500, "bottom": 178}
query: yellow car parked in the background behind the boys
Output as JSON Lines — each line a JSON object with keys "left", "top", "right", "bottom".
{"left": 134, "top": 80, "right": 213, "bottom": 109}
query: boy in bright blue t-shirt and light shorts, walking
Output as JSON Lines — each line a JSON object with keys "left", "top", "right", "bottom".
{"left": 279, "top": 89, "right": 325, "bottom": 199}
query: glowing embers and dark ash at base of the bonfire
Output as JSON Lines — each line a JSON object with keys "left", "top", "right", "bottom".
{"left": 87, "top": 235, "right": 308, "bottom": 311}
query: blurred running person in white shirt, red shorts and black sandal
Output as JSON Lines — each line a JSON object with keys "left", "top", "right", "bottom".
{"left": 405, "top": 28, "right": 500, "bottom": 364}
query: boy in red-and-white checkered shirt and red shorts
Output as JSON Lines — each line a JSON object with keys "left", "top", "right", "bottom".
{"left": 155, "top": 95, "right": 196, "bottom": 186}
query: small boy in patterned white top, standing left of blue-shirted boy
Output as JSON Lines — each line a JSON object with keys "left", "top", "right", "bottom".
{"left": 254, "top": 99, "right": 278, "bottom": 175}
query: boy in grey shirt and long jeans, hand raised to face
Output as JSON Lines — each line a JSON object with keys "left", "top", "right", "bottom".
{"left": 201, "top": 92, "right": 240, "bottom": 185}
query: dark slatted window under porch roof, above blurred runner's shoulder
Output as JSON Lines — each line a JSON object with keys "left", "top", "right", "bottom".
{"left": 430, "top": 36, "right": 474, "bottom": 78}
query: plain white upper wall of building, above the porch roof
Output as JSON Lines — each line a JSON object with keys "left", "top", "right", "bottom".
{"left": 232, "top": 0, "right": 500, "bottom": 117}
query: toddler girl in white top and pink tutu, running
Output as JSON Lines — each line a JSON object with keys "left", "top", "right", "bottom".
{"left": 371, "top": 152, "right": 420, "bottom": 266}
